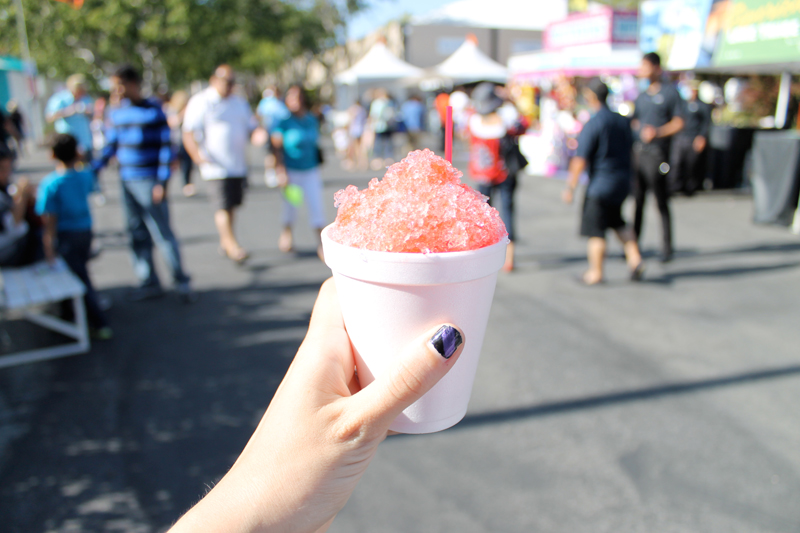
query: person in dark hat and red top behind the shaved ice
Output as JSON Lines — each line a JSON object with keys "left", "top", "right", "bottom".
{"left": 467, "top": 82, "right": 524, "bottom": 272}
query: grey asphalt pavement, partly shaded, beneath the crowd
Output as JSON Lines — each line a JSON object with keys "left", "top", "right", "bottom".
{"left": 0, "top": 142, "right": 800, "bottom": 533}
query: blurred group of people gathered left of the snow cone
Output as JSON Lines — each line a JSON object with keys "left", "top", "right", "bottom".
{"left": 0, "top": 61, "right": 334, "bottom": 339}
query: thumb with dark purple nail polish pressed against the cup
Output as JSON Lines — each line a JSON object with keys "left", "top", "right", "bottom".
{"left": 353, "top": 324, "right": 465, "bottom": 431}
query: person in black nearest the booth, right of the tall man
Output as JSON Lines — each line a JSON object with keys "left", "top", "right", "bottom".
{"left": 669, "top": 80, "right": 711, "bottom": 196}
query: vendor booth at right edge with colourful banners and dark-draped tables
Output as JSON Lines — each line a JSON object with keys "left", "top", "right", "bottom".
{"left": 640, "top": 0, "right": 800, "bottom": 225}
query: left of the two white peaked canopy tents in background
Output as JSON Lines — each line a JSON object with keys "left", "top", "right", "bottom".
{"left": 334, "top": 42, "right": 423, "bottom": 109}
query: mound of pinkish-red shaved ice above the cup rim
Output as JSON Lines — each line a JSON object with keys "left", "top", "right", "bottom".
{"left": 329, "top": 150, "right": 508, "bottom": 253}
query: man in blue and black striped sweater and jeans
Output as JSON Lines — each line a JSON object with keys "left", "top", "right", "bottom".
{"left": 92, "top": 65, "right": 196, "bottom": 303}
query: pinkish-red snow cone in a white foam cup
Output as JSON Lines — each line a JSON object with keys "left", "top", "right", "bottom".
{"left": 322, "top": 150, "right": 508, "bottom": 433}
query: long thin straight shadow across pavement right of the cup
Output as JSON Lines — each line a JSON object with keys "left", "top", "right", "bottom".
{"left": 452, "top": 365, "right": 800, "bottom": 429}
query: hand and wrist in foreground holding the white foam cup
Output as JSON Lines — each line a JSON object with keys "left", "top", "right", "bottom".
{"left": 171, "top": 279, "right": 463, "bottom": 533}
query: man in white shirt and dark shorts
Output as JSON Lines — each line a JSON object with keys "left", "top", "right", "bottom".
{"left": 183, "top": 65, "right": 266, "bottom": 264}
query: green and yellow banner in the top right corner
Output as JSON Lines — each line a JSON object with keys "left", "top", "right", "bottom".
{"left": 713, "top": 0, "right": 800, "bottom": 67}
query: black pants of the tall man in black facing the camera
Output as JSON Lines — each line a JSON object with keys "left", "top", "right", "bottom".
{"left": 633, "top": 144, "right": 672, "bottom": 256}
